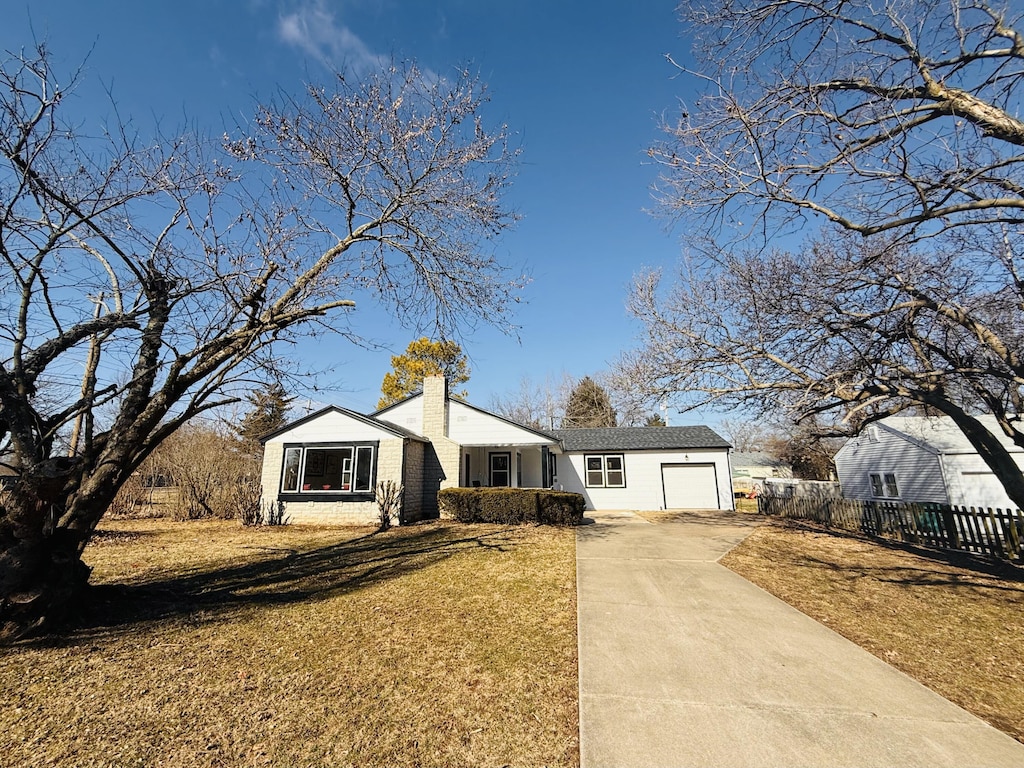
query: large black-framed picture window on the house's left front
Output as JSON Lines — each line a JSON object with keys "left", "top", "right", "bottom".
{"left": 281, "top": 445, "right": 376, "bottom": 494}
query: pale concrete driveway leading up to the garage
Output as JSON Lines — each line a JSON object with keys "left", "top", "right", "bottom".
{"left": 577, "top": 512, "right": 1024, "bottom": 768}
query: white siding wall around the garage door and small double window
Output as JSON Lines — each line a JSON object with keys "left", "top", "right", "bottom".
{"left": 557, "top": 449, "right": 733, "bottom": 510}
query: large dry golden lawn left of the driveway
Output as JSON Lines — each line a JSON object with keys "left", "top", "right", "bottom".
{"left": 0, "top": 519, "right": 579, "bottom": 768}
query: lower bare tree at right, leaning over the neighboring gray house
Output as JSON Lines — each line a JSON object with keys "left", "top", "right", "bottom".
{"left": 624, "top": 236, "right": 1024, "bottom": 507}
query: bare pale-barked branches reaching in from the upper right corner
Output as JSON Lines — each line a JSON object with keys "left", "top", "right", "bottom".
{"left": 651, "top": 0, "right": 1024, "bottom": 240}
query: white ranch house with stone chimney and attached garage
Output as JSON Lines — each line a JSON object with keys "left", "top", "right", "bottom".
{"left": 262, "top": 376, "right": 732, "bottom": 524}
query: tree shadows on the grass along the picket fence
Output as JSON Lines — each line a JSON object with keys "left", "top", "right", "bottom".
{"left": 772, "top": 520, "right": 1024, "bottom": 593}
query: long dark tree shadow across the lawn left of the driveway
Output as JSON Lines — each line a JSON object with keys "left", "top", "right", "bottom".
{"left": 41, "top": 524, "right": 519, "bottom": 645}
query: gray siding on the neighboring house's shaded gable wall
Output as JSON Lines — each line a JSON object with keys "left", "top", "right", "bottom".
{"left": 836, "top": 426, "right": 949, "bottom": 504}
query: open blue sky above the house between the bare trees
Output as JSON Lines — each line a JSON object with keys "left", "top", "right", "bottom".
{"left": 0, "top": 0, "right": 700, "bottom": 424}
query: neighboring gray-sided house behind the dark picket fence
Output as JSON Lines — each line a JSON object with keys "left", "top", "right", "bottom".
{"left": 836, "top": 416, "right": 1024, "bottom": 509}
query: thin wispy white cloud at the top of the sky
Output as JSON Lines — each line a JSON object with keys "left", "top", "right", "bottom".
{"left": 278, "top": 0, "right": 386, "bottom": 71}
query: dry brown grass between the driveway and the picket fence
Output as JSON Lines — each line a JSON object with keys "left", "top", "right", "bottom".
{"left": 722, "top": 522, "right": 1024, "bottom": 741}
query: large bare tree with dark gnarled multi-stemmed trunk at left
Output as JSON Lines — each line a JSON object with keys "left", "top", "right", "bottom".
{"left": 0, "top": 47, "right": 519, "bottom": 639}
